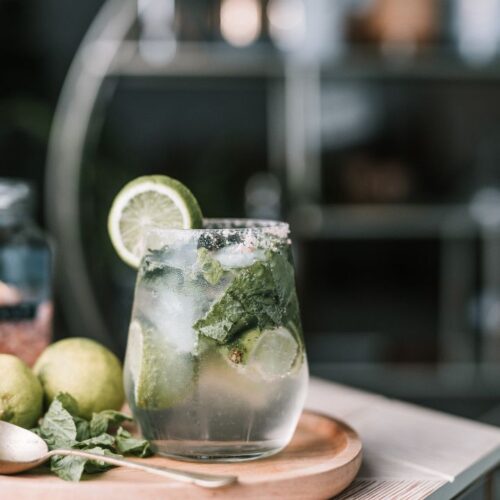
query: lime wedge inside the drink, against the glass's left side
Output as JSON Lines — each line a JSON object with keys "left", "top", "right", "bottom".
{"left": 126, "top": 320, "right": 194, "bottom": 410}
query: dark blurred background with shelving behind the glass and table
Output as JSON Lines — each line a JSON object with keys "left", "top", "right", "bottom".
{"left": 4, "top": 0, "right": 500, "bottom": 424}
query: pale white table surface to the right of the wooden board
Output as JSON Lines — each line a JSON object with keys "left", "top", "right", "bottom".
{"left": 306, "top": 378, "right": 500, "bottom": 500}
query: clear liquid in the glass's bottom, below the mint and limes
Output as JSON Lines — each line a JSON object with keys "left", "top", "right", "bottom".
{"left": 127, "top": 354, "right": 308, "bottom": 461}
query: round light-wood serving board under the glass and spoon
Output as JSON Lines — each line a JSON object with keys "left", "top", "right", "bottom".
{"left": 0, "top": 412, "right": 361, "bottom": 500}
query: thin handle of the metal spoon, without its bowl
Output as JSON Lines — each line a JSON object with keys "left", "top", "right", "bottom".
{"left": 46, "top": 449, "right": 237, "bottom": 488}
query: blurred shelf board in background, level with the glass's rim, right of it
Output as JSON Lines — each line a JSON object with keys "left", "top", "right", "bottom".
{"left": 289, "top": 204, "right": 478, "bottom": 239}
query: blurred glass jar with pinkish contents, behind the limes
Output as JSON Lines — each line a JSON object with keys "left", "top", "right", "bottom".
{"left": 0, "top": 178, "right": 53, "bottom": 365}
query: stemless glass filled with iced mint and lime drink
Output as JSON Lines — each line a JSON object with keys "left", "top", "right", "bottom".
{"left": 125, "top": 219, "right": 308, "bottom": 461}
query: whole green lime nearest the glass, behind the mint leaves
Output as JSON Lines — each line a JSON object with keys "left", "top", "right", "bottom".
{"left": 33, "top": 337, "right": 125, "bottom": 418}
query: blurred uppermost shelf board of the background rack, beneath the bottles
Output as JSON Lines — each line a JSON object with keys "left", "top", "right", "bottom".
{"left": 92, "top": 41, "right": 500, "bottom": 81}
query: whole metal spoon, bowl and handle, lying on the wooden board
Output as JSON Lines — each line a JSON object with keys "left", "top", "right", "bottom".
{"left": 0, "top": 421, "right": 237, "bottom": 488}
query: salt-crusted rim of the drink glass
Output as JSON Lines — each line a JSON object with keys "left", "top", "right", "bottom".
{"left": 146, "top": 218, "right": 291, "bottom": 250}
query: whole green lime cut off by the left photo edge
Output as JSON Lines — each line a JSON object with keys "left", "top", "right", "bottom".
{"left": 0, "top": 354, "right": 43, "bottom": 428}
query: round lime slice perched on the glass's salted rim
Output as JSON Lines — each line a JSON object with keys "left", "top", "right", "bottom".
{"left": 108, "top": 175, "right": 203, "bottom": 268}
